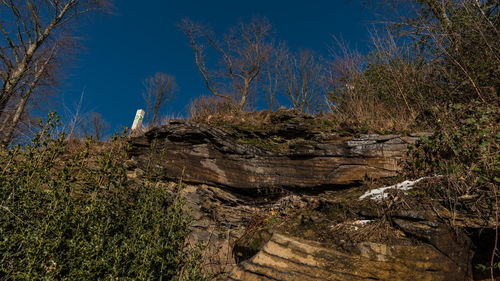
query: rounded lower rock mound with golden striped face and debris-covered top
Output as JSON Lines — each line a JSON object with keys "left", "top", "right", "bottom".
{"left": 224, "top": 180, "right": 474, "bottom": 280}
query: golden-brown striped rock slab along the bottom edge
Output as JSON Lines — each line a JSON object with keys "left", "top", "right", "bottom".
{"left": 228, "top": 233, "right": 466, "bottom": 281}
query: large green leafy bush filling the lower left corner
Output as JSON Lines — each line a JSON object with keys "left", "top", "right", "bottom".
{"left": 0, "top": 113, "right": 205, "bottom": 280}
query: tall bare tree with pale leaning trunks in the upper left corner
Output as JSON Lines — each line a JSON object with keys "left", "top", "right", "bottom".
{"left": 0, "top": 0, "right": 109, "bottom": 146}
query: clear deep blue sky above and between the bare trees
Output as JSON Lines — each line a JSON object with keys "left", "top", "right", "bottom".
{"left": 57, "top": 0, "right": 373, "bottom": 131}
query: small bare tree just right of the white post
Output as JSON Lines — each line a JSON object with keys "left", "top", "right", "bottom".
{"left": 142, "top": 73, "right": 177, "bottom": 126}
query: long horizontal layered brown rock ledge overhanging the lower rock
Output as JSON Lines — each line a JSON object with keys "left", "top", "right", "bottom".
{"left": 130, "top": 120, "right": 417, "bottom": 192}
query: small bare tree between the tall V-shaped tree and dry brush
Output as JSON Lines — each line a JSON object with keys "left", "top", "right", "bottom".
{"left": 283, "top": 51, "right": 328, "bottom": 113}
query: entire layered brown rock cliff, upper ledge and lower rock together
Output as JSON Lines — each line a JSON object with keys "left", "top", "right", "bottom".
{"left": 129, "top": 111, "right": 494, "bottom": 280}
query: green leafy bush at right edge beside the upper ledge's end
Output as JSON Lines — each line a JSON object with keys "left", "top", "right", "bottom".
{"left": 409, "top": 101, "right": 500, "bottom": 201}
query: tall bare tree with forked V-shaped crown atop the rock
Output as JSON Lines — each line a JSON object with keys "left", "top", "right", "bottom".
{"left": 180, "top": 18, "right": 271, "bottom": 109}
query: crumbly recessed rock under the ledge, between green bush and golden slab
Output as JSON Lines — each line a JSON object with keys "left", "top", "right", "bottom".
{"left": 178, "top": 183, "right": 309, "bottom": 280}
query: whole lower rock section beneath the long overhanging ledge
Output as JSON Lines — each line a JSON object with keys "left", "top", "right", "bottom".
{"left": 134, "top": 178, "right": 473, "bottom": 281}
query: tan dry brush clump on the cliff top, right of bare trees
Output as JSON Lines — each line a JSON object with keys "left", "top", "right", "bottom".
{"left": 328, "top": 34, "right": 441, "bottom": 132}
